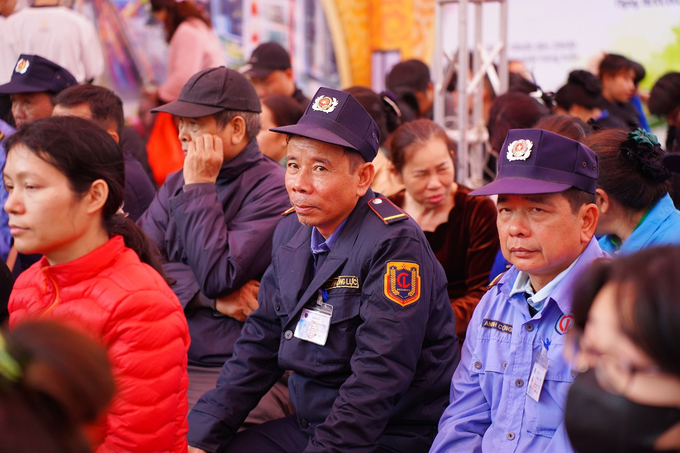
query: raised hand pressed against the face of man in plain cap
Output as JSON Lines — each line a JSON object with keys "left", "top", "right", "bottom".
{"left": 184, "top": 134, "right": 224, "bottom": 184}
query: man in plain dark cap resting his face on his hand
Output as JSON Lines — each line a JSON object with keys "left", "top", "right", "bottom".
{"left": 138, "top": 67, "right": 290, "bottom": 416}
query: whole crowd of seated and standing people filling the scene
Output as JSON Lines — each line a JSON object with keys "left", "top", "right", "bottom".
{"left": 0, "top": 0, "right": 680, "bottom": 453}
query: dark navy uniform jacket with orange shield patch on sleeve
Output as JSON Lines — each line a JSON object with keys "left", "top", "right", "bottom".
{"left": 188, "top": 190, "right": 459, "bottom": 453}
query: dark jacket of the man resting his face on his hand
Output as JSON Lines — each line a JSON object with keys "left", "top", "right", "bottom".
{"left": 138, "top": 140, "right": 290, "bottom": 366}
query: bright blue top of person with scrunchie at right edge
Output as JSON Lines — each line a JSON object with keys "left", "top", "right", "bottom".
{"left": 599, "top": 194, "right": 680, "bottom": 255}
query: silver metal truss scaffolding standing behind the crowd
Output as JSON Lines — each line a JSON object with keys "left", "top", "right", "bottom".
{"left": 433, "top": 0, "right": 508, "bottom": 188}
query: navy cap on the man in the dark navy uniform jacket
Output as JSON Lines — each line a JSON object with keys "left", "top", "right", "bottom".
{"left": 270, "top": 87, "right": 380, "bottom": 162}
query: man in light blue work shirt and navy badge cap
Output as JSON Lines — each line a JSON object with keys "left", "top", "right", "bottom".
{"left": 431, "top": 129, "right": 607, "bottom": 453}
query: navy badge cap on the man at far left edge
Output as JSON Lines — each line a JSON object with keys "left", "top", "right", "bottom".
{"left": 0, "top": 54, "right": 78, "bottom": 94}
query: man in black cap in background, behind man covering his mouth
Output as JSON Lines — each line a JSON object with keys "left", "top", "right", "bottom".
{"left": 241, "top": 42, "right": 309, "bottom": 110}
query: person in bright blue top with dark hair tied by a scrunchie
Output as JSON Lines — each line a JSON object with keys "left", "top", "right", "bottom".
{"left": 585, "top": 129, "right": 680, "bottom": 255}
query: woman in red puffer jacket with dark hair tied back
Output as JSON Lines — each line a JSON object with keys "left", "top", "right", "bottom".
{"left": 4, "top": 117, "right": 189, "bottom": 452}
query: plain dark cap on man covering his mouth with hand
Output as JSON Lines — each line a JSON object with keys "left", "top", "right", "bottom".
{"left": 151, "top": 66, "right": 262, "bottom": 118}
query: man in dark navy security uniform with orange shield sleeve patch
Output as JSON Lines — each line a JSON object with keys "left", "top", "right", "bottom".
{"left": 188, "top": 88, "right": 459, "bottom": 453}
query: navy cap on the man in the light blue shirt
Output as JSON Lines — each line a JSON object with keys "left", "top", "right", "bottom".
{"left": 470, "top": 129, "right": 598, "bottom": 195}
